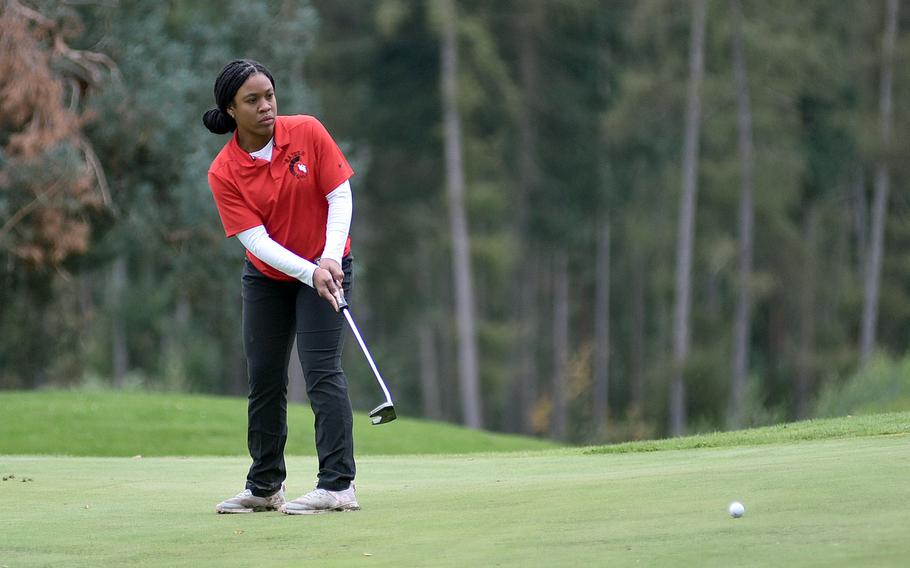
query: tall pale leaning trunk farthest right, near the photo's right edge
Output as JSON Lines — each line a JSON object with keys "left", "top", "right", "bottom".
{"left": 860, "top": 0, "right": 897, "bottom": 366}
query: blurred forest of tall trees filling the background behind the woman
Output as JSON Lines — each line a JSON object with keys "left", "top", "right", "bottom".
{"left": 0, "top": 0, "right": 910, "bottom": 443}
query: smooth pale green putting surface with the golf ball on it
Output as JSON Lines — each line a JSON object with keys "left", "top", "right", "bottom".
{"left": 0, "top": 425, "right": 910, "bottom": 568}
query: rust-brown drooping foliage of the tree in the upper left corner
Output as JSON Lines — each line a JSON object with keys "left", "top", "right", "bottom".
{"left": 0, "top": 0, "right": 118, "bottom": 269}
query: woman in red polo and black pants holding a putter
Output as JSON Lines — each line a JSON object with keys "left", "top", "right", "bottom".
{"left": 203, "top": 60, "right": 360, "bottom": 514}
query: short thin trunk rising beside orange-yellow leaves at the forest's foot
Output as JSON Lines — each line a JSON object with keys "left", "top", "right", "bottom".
{"left": 551, "top": 250, "right": 569, "bottom": 440}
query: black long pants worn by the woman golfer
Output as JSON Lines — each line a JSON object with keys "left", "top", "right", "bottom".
{"left": 243, "top": 256, "right": 355, "bottom": 497}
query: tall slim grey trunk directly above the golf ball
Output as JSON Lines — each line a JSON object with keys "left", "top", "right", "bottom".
{"left": 730, "top": 0, "right": 754, "bottom": 428}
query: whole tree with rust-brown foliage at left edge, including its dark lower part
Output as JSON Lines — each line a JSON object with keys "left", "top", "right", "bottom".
{"left": 0, "top": 0, "right": 119, "bottom": 386}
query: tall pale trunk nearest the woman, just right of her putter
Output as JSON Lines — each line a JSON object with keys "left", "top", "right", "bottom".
{"left": 440, "top": 0, "right": 483, "bottom": 428}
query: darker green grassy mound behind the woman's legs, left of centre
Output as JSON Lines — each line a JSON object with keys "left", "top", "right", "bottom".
{"left": 0, "top": 391, "right": 556, "bottom": 457}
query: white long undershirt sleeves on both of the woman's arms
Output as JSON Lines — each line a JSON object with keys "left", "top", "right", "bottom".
{"left": 237, "top": 180, "right": 354, "bottom": 287}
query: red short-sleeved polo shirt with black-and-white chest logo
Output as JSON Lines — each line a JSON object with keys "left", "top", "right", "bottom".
{"left": 209, "top": 115, "right": 354, "bottom": 280}
